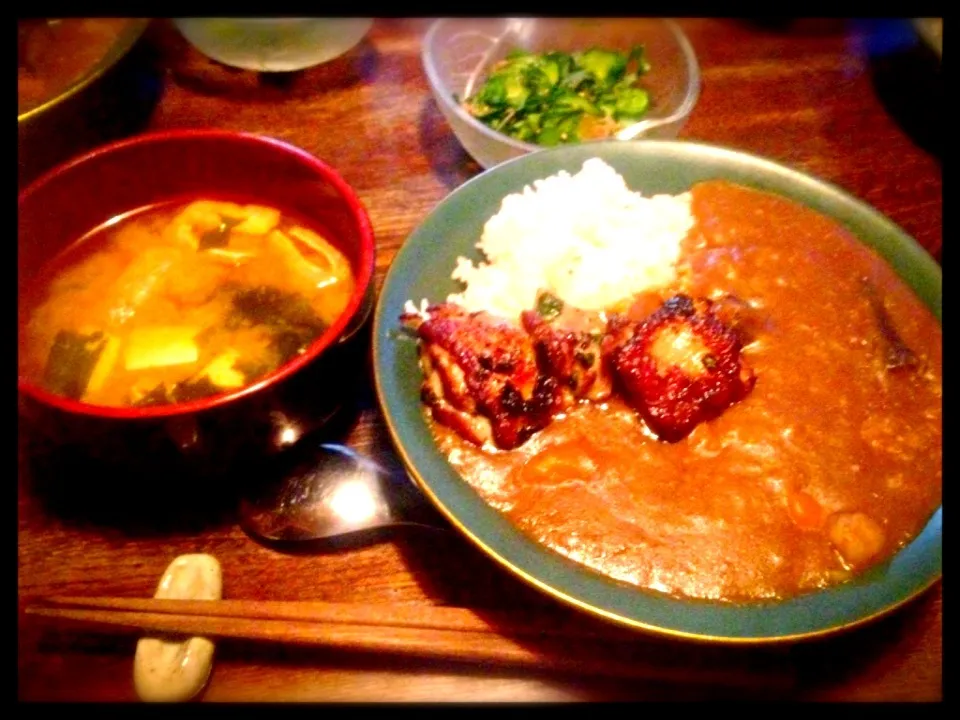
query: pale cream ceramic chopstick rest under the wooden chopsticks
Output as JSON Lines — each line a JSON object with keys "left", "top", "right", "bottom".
{"left": 133, "top": 554, "right": 223, "bottom": 702}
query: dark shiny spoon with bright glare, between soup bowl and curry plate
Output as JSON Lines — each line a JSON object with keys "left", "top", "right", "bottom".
{"left": 240, "top": 441, "right": 446, "bottom": 546}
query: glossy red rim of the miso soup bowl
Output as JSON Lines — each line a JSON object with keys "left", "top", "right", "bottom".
{"left": 17, "top": 128, "right": 376, "bottom": 420}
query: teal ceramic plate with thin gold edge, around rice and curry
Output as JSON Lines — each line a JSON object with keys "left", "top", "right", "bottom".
{"left": 373, "top": 140, "right": 942, "bottom": 643}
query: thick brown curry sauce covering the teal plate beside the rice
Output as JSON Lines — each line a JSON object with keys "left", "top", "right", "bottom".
{"left": 433, "top": 181, "right": 942, "bottom": 601}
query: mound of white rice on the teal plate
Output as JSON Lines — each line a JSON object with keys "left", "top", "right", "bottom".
{"left": 438, "top": 158, "right": 693, "bottom": 320}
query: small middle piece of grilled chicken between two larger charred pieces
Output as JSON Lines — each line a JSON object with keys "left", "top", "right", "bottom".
{"left": 520, "top": 296, "right": 613, "bottom": 409}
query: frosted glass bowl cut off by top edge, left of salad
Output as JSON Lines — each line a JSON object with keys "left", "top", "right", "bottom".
{"left": 173, "top": 18, "right": 373, "bottom": 72}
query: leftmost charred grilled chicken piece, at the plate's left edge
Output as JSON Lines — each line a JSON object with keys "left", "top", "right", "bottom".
{"left": 401, "top": 303, "right": 559, "bottom": 449}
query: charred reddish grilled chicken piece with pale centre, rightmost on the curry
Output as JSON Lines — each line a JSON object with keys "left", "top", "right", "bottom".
{"left": 604, "top": 295, "right": 756, "bottom": 442}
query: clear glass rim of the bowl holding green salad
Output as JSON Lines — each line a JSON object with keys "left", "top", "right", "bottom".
{"left": 420, "top": 17, "right": 700, "bottom": 153}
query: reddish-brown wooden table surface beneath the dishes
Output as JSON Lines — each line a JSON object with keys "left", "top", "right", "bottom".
{"left": 18, "top": 18, "right": 943, "bottom": 702}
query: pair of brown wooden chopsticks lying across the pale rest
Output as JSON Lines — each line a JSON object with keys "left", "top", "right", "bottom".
{"left": 25, "top": 597, "right": 795, "bottom": 688}
